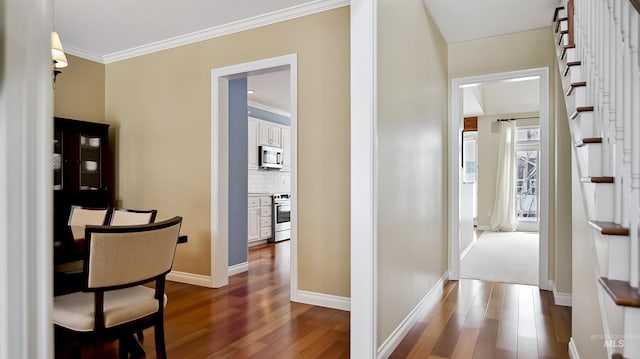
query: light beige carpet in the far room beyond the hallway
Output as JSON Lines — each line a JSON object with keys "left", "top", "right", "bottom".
{"left": 460, "top": 232, "right": 538, "bottom": 286}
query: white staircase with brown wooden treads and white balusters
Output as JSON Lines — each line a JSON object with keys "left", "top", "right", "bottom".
{"left": 553, "top": 0, "right": 640, "bottom": 358}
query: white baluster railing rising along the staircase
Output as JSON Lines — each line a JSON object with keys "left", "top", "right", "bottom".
{"left": 567, "top": 0, "right": 640, "bottom": 292}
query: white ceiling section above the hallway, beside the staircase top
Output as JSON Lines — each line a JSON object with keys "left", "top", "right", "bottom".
{"left": 423, "top": 0, "right": 560, "bottom": 44}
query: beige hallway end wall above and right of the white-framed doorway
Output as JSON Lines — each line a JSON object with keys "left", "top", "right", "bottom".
{"left": 449, "top": 27, "right": 571, "bottom": 293}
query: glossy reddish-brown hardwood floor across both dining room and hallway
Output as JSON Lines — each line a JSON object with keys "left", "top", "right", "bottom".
{"left": 56, "top": 241, "right": 571, "bottom": 359}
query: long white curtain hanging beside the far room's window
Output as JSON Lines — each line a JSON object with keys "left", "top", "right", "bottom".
{"left": 489, "top": 121, "right": 518, "bottom": 232}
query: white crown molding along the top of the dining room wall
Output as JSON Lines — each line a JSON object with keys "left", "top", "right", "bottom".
{"left": 100, "top": 0, "right": 349, "bottom": 64}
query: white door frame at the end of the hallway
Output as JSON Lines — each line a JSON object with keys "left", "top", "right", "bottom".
{"left": 449, "top": 67, "right": 550, "bottom": 290}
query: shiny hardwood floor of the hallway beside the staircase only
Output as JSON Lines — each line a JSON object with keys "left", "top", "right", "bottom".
{"left": 391, "top": 279, "right": 571, "bottom": 359}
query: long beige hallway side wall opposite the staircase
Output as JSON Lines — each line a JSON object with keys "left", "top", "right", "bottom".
{"left": 378, "top": 0, "right": 447, "bottom": 347}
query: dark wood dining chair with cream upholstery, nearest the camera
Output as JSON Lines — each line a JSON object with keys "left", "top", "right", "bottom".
{"left": 53, "top": 217, "right": 182, "bottom": 358}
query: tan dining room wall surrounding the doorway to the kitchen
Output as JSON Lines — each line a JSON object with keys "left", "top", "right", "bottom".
{"left": 106, "top": 7, "right": 350, "bottom": 296}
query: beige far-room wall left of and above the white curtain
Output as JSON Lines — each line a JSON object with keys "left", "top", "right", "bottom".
{"left": 478, "top": 112, "right": 540, "bottom": 227}
